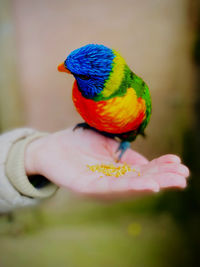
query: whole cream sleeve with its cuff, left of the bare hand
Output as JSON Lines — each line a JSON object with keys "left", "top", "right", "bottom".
{"left": 0, "top": 128, "right": 57, "bottom": 215}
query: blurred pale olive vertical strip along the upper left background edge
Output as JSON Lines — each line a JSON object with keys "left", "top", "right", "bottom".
{"left": 0, "top": 0, "right": 24, "bottom": 131}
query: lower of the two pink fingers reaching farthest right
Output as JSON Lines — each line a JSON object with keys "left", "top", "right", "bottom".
{"left": 154, "top": 173, "right": 187, "bottom": 188}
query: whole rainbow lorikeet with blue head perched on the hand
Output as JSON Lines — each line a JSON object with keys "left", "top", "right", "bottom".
{"left": 58, "top": 44, "right": 151, "bottom": 160}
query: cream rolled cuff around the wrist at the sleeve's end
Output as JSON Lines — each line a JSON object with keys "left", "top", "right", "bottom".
{"left": 6, "top": 133, "right": 58, "bottom": 199}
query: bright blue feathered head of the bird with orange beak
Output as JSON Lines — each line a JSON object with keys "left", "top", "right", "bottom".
{"left": 58, "top": 44, "right": 115, "bottom": 98}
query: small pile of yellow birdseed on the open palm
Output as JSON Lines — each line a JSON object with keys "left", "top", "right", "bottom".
{"left": 86, "top": 163, "right": 141, "bottom": 177}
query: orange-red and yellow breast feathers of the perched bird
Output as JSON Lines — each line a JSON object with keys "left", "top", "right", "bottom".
{"left": 72, "top": 81, "right": 146, "bottom": 134}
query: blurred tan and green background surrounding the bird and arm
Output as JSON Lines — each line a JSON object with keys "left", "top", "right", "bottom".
{"left": 0, "top": 0, "right": 200, "bottom": 267}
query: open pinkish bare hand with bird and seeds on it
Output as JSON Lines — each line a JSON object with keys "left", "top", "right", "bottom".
{"left": 25, "top": 128, "right": 189, "bottom": 199}
